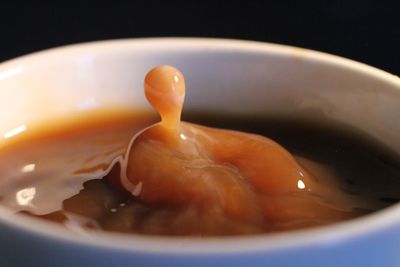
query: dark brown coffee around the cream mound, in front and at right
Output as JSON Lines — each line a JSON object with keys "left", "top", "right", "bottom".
{"left": 6, "top": 112, "right": 400, "bottom": 236}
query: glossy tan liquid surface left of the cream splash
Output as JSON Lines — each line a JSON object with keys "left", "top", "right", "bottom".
{"left": 0, "top": 110, "right": 156, "bottom": 214}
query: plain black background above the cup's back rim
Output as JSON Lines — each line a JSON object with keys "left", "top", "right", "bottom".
{"left": 0, "top": 0, "right": 400, "bottom": 75}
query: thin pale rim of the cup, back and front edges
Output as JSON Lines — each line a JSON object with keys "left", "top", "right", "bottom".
{"left": 0, "top": 38, "right": 400, "bottom": 254}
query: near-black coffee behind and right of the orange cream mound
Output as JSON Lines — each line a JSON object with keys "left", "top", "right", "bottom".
{"left": 188, "top": 116, "right": 400, "bottom": 208}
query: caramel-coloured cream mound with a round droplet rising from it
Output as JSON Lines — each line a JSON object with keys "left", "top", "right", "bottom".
{"left": 123, "top": 66, "right": 354, "bottom": 224}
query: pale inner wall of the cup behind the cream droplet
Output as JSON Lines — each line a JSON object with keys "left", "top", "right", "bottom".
{"left": 0, "top": 39, "right": 400, "bottom": 151}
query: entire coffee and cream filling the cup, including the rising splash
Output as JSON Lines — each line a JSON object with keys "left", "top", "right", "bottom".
{"left": 0, "top": 66, "right": 399, "bottom": 236}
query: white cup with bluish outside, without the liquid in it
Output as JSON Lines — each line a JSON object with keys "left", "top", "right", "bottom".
{"left": 0, "top": 38, "right": 400, "bottom": 266}
